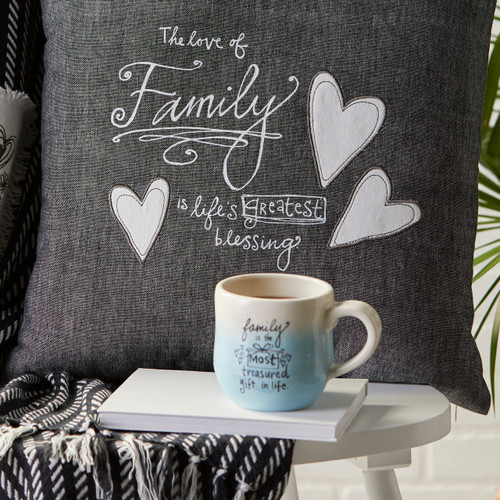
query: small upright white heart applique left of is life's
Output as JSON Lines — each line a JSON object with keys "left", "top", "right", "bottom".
{"left": 109, "top": 177, "right": 170, "bottom": 262}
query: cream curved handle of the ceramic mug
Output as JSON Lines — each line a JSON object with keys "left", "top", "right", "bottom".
{"left": 327, "top": 300, "right": 382, "bottom": 379}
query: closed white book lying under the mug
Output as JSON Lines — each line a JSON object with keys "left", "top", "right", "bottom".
{"left": 98, "top": 368, "right": 368, "bottom": 441}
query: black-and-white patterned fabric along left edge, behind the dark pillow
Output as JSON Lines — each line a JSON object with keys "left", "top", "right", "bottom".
{"left": 0, "top": 0, "right": 44, "bottom": 357}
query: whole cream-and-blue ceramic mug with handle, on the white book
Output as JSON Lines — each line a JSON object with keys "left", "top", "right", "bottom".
{"left": 214, "top": 273, "right": 381, "bottom": 411}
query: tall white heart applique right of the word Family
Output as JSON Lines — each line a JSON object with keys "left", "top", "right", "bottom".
{"left": 309, "top": 71, "right": 385, "bottom": 188}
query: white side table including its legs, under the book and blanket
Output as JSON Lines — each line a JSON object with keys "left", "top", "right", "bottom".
{"left": 282, "top": 383, "right": 451, "bottom": 500}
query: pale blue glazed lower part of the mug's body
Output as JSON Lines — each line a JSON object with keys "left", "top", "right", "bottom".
{"left": 214, "top": 318, "right": 333, "bottom": 411}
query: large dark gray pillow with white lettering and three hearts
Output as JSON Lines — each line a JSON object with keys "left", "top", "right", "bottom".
{"left": 4, "top": 0, "right": 495, "bottom": 413}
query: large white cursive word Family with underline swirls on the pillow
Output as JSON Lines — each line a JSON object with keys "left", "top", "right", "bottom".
{"left": 111, "top": 60, "right": 299, "bottom": 191}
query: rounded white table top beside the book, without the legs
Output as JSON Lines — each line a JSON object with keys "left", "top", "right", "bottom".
{"left": 294, "top": 383, "right": 451, "bottom": 464}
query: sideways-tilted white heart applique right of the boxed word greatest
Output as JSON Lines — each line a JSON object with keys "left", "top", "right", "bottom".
{"left": 329, "top": 168, "right": 422, "bottom": 248}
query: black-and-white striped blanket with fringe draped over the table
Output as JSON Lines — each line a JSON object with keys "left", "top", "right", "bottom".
{"left": 0, "top": 372, "right": 293, "bottom": 500}
